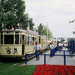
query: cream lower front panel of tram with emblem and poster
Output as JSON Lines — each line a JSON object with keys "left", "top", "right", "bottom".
{"left": 0, "top": 45, "right": 22, "bottom": 57}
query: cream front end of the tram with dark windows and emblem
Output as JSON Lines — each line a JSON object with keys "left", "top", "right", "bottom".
{"left": 0, "top": 25, "right": 24, "bottom": 58}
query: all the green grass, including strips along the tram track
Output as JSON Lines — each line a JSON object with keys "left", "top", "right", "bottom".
{"left": 0, "top": 49, "right": 49, "bottom": 75}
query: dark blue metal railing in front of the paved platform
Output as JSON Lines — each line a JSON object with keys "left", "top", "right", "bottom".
{"left": 25, "top": 50, "right": 75, "bottom": 65}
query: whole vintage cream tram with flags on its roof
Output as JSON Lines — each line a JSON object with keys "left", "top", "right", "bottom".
{"left": 0, "top": 25, "right": 47, "bottom": 59}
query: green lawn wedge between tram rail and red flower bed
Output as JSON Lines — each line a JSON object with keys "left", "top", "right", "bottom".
{"left": 0, "top": 65, "right": 37, "bottom": 75}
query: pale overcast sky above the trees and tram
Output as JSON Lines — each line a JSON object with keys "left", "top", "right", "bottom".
{"left": 25, "top": 0, "right": 75, "bottom": 38}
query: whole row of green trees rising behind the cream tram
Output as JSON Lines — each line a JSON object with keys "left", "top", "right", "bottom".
{"left": 0, "top": 0, "right": 52, "bottom": 38}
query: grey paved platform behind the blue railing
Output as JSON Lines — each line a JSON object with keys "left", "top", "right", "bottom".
{"left": 27, "top": 49, "right": 75, "bottom": 65}
